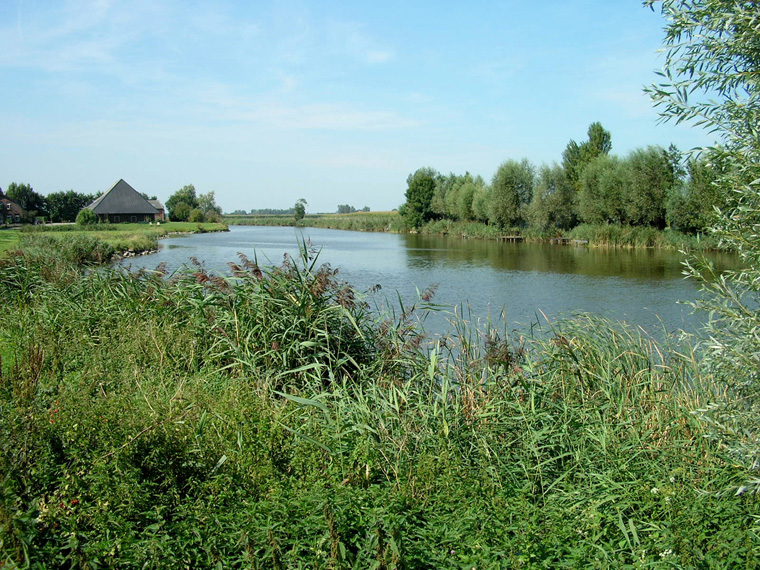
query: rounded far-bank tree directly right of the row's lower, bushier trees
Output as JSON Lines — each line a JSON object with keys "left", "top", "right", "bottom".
{"left": 489, "top": 158, "right": 534, "bottom": 229}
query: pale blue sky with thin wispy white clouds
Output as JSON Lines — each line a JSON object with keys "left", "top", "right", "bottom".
{"left": 0, "top": 0, "right": 713, "bottom": 212}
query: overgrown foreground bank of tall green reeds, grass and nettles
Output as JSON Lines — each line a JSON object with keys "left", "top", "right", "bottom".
{"left": 0, "top": 236, "right": 760, "bottom": 569}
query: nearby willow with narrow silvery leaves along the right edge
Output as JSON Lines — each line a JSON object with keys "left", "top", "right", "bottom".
{"left": 645, "top": 0, "right": 760, "bottom": 493}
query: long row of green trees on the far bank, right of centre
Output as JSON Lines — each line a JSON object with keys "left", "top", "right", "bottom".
{"left": 399, "top": 123, "right": 724, "bottom": 233}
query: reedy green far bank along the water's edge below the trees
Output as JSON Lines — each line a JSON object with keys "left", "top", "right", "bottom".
{"left": 223, "top": 212, "right": 721, "bottom": 251}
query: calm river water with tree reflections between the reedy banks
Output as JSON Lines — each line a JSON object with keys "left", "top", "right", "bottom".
{"left": 120, "top": 226, "right": 731, "bottom": 336}
